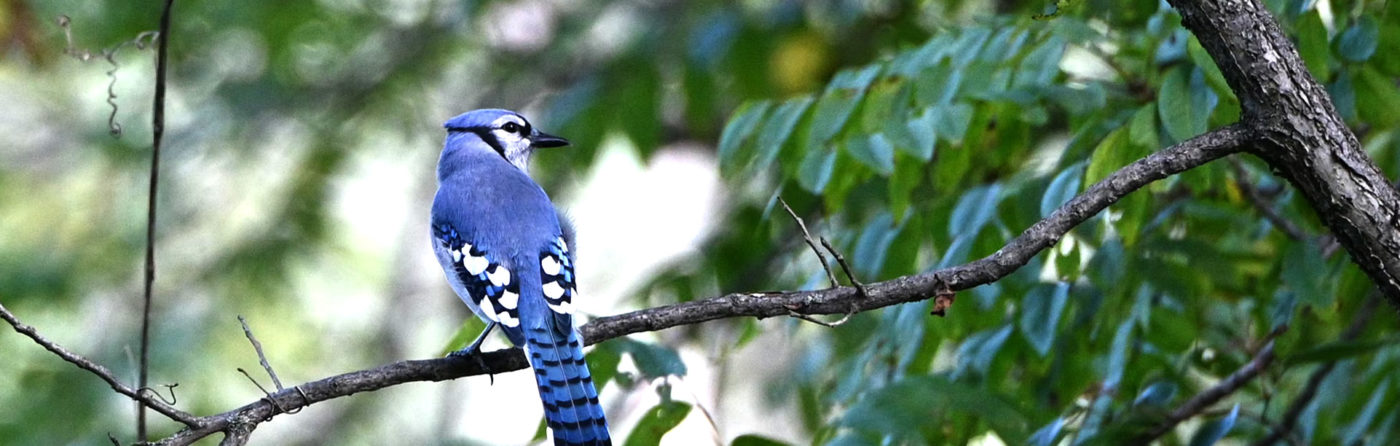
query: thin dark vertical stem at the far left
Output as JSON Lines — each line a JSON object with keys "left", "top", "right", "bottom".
{"left": 136, "top": 0, "right": 175, "bottom": 442}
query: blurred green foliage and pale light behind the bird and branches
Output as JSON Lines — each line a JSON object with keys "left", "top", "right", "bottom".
{"left": 0, "top": 0, "right": 1400, "bottom": 445}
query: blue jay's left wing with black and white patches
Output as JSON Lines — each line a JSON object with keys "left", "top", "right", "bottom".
{"left": 433, "top": 224, "right": 525, "bottom": 345}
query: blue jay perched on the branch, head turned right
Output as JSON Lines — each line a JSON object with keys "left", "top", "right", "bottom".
{"left": 433, "top": 109, "right": 612, "bottom": 445}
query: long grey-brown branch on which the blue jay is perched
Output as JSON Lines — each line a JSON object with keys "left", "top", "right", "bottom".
{"left": 133, "top": 126, "right": 1247, "bottom": 446}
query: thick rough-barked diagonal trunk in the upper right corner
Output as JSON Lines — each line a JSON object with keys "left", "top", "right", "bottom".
{"left": 1169, "top": 0, "right": 1400, "bottom": 306}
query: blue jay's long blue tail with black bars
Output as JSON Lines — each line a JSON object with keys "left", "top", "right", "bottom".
{"left": 524, "top": 324, "right": 612, "bottom": 445}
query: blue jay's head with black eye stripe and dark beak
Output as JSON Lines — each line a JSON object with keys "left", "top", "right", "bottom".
{"left": 442, "top": 109, "right": 568, "bottom": 172}
